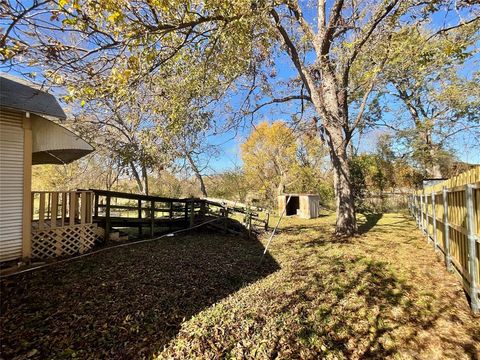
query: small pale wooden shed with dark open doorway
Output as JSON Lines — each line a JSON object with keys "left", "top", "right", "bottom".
{"left": 278, "top": 194, "right": 320, "bottom": 219}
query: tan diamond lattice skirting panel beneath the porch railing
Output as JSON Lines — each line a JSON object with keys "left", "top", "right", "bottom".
{"left": 32, "top": 224, "right": 98, "bottom": 259}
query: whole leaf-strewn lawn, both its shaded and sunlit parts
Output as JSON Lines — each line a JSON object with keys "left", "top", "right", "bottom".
{"left": 0, "top": 214, "right": 480, "bottom": 359}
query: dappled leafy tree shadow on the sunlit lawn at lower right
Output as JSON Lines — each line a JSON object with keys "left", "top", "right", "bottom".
{"left": 264, "top": 256, "right": 480, "bottom": 359}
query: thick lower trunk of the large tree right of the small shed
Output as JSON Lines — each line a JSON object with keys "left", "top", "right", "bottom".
{"left": 325, "top": 127, "right": 357, "bottom": 236}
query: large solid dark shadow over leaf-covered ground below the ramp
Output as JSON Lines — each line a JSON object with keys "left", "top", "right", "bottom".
{"left": 0, "top": 229, "right": 279, "bottom": 359}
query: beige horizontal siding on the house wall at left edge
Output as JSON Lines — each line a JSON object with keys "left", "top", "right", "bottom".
{"left": 0, "top": 109, "right": 24, "bottom": 261}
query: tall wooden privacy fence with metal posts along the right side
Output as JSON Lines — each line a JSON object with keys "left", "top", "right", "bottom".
{"left": 409, "top": 167, "right": 480, "bottom": 313}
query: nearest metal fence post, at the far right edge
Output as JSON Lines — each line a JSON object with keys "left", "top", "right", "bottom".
{"left": 465, "top": 184, "right": 480, "bottom": 313}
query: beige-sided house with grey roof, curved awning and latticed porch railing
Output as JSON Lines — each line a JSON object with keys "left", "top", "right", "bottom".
{"left": 0, "top": 73, "right": 94, "bottom": 262}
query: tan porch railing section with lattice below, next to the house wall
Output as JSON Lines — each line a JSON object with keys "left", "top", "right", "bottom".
{"left": 31, "top": 191, "right": 97, "bottom": 259}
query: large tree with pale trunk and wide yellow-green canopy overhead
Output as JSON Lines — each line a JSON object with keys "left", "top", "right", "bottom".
{"left": 0, "top": 0, "right": 479, "bottom": 235}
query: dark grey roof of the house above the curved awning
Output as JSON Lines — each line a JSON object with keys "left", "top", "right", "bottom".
{"left": 0, "top": 73, "right": 67, "bottom": 119}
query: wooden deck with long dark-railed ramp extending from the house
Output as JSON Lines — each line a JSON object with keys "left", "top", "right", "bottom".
{"left": 31, "top": 189, "right": 268, "bottom": 259}
